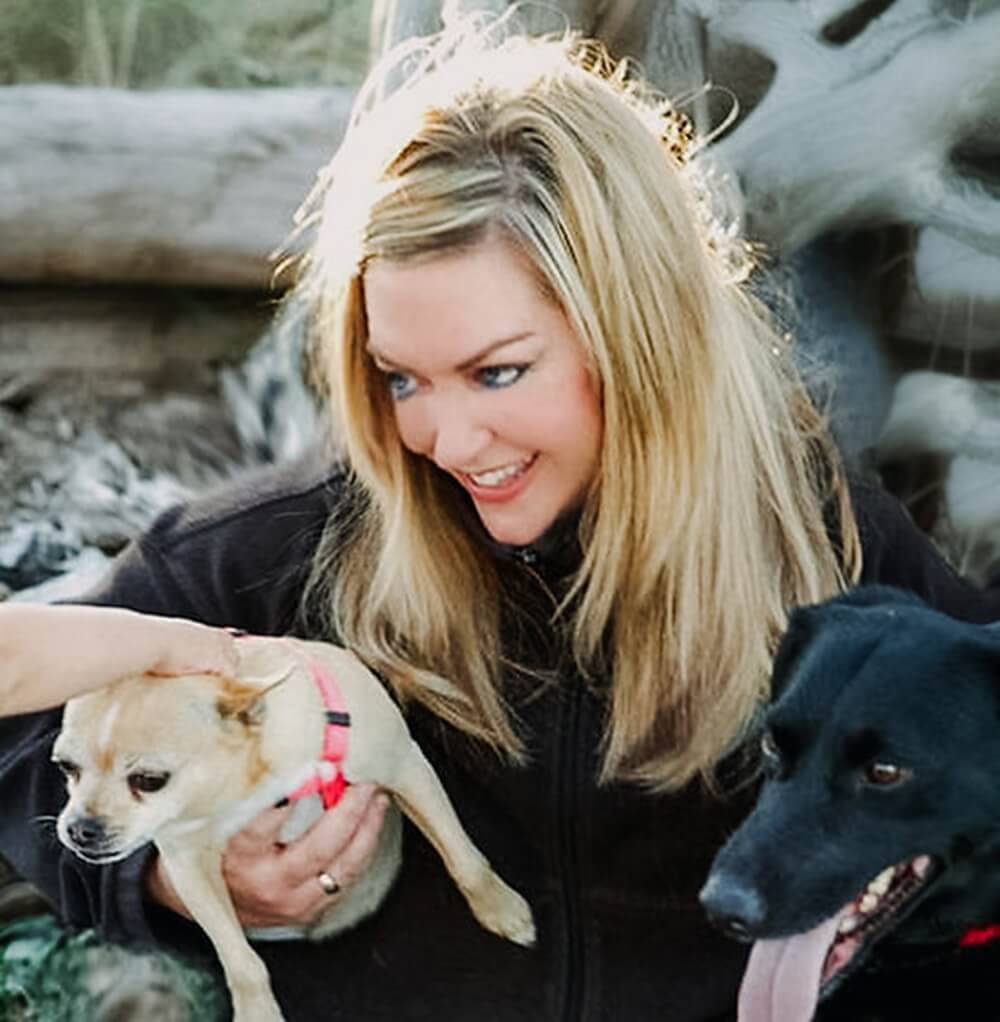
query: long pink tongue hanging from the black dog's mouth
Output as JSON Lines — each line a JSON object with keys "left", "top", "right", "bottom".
{"left": 738, "top": 913, "right": 840, "bottom": 1022}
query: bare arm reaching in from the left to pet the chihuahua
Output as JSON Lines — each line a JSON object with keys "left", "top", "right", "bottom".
{"left": 0, "top": 604, "right": 236, "bottom": 713}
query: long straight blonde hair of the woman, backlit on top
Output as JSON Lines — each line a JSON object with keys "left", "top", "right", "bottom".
{"left": 294, "top": 21, "right": 860, "bottom": 789}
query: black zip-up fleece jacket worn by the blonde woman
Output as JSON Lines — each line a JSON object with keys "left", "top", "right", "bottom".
{"left": 0, "top": 462, "right": 1000, "bottom": 1022}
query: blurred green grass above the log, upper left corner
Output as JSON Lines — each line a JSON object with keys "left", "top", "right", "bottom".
{"left": 0, "top": 0, "right": 371, "bottom": 89}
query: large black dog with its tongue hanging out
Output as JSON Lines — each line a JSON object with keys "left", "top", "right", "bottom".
{"left": 701, "top": 587, "right": 1000, "bottom": 1022}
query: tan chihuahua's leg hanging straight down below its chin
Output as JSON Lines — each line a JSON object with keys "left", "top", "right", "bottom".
{"left": 156, "top": 842, "right": 283, "bottom": 1022}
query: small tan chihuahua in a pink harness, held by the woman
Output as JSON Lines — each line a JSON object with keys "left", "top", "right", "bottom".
{"left": 52, "top": 637, "right": 535, "bottom": 1022}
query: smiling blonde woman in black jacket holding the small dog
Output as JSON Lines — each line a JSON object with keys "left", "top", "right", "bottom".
{"left": 0, "top": 24, "right": 994, "bottom": 1022}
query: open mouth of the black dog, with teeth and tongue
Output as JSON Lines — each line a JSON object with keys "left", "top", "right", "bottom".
{"left": 739, "top": 855, "right": 938, "bottom": 1022}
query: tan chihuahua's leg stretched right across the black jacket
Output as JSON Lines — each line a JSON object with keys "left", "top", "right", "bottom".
{"left": 387, "top": 741, "right": 535, "bottom": 945}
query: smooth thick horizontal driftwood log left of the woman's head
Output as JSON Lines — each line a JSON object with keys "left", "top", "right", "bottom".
{"left": 0, "top": 86, "right": 352, "bottom": 289}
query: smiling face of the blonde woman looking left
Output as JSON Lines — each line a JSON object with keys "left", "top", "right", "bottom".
{"left": 365, "top": 240, "right": 602, "bottom": 545}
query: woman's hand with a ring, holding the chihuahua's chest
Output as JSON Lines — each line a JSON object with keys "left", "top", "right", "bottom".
{"left": 147, "top": 784, "right": 389, "bottom": 927}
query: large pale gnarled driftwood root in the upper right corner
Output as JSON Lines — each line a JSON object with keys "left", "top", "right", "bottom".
{"left": 688, "top": 0, "right": 1000, "bottom": 256}
